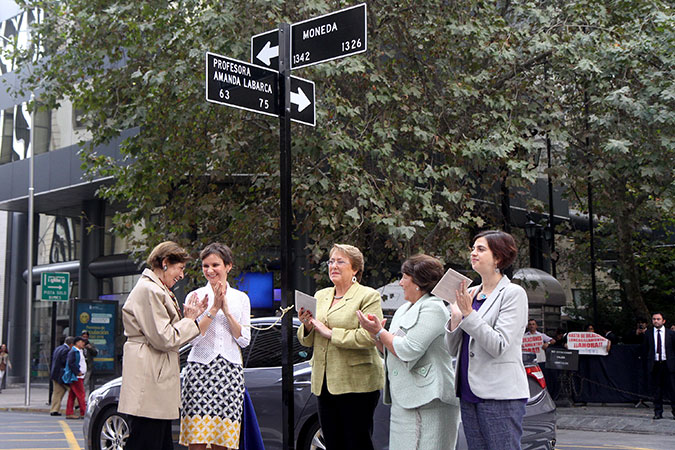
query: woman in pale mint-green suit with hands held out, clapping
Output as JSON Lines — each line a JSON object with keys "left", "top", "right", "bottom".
{"left": 357, "top": 255, "right": 459, "bottom": 450}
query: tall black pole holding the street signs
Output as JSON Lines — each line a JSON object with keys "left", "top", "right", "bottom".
{"left": 278, "top": 23, "right": 295, "bottom": 450}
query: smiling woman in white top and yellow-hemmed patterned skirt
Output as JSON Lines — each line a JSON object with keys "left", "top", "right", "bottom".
{"left": 180, "top": 243, "right": 251, "bottom": 450}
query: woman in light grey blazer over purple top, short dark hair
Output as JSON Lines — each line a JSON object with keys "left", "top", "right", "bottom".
{"left": 446, "top": 231, "right": 529, "bottom": 450}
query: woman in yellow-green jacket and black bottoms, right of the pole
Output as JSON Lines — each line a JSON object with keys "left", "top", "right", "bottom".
{"left": 298, "top": 244, "right": 384, "bottom": 450}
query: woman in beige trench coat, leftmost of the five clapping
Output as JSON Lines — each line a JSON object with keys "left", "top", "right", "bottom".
{"left": 118, "top": 241, "right": 223, "bottom": 450}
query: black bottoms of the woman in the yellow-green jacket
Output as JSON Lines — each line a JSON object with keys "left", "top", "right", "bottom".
{"left": 317, "top": 380, "right": 380, "bottom": 450}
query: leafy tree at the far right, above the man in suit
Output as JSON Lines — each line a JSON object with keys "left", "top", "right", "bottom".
{"left": 552, "top": 1, "right": 675, "bottom": 317}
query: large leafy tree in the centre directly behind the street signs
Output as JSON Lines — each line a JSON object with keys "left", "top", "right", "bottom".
{"left": 10, "top": 0, "right": 547, "bottom": 279}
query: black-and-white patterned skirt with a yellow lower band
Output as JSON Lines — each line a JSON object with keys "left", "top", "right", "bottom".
{"left": 180, "top": 356, "right": 244, "bottom": 449}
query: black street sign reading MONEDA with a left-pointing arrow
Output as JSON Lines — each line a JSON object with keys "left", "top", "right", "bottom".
{"left": 251, "top": 3, "right": 368, "bottom": 70}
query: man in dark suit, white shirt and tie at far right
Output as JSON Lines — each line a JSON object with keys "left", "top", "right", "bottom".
{"left": 643, "top": 312, "right": 675, "bottom": 420}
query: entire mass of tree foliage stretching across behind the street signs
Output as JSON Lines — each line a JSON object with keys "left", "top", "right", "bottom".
{"left": 10, "top": 0, "right": 675, "bottom": 312}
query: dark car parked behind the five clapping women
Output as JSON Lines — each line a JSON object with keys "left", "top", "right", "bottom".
{"left": 84, "top": 317, "right": 555, "bottom": 450}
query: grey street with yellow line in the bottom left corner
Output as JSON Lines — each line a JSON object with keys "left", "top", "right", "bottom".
{"left": 0, "top": 411, "right": 84, "bottom": 450}
